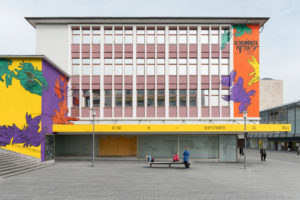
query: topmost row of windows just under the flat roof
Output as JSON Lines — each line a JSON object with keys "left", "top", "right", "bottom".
{"left": 72, "top": 27, "right": 228, "bottom": 44}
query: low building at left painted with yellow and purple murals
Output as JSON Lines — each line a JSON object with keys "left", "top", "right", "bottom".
{"left": 0, "top": 55, "right": 69, "bottom": 161}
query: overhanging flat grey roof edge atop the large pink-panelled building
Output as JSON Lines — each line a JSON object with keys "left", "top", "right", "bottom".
{"left": 25, "top": 17, "right": 269, "bottom": 28}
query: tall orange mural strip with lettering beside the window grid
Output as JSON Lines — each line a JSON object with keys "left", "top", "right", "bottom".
{"left": 232, "top": 25, "right": 259, "bottom": 117}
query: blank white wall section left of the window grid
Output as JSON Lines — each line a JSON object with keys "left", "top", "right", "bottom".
{"left": 36, "top": 25, "right": 69, "bottom": 72}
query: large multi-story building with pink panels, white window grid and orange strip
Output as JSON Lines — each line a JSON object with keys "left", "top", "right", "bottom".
{"left": 26, "top": 17, "right": 268, "bottom": 161}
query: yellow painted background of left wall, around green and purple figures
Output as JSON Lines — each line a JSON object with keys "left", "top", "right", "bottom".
{"left": 0, "top": 58, "right": 42, "bottom": 158}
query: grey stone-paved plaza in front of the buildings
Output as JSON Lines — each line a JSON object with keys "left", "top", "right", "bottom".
{"left": 0, "top": 150, "right": 300, "bottom": 200}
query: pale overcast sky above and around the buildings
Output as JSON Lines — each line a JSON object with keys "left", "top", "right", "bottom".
{"left": 0, "top": 0, "right": 300, "bottom": 103}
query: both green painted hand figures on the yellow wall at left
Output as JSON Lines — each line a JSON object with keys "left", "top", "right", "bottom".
{"left": 0, "top": 59, "right": 48, "bottom": 96}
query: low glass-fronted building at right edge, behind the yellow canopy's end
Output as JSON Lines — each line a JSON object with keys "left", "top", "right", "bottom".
{"left": 250, "top": 101, "right": 300, "bottom": 150}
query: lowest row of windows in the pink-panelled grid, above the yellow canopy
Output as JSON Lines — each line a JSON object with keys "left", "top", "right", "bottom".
{"left": 73, "top": 89, "right": 229, "bottom": 107}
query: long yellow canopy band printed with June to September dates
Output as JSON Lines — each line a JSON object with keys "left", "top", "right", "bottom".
{"left": 53, "top": 124, "right": 291, "bottom": 133}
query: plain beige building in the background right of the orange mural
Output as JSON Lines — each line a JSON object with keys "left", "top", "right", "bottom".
{"left": 259, "top": 78, "right": 283, "bottom": 110}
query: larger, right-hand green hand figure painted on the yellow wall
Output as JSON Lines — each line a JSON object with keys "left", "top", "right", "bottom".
{"left": 16, "top": 62, "right": 48, "bottom": 96}
